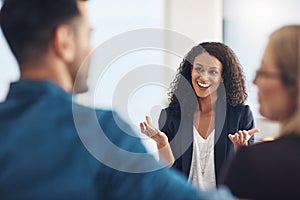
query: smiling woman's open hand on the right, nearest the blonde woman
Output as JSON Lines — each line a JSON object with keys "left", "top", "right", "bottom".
{"left": 228, "top": 128, "right": 259, "bottom": 150}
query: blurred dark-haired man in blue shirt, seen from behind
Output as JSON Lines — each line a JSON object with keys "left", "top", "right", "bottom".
{"left": 0, "top": 0, "right": 231, "bottom": 200}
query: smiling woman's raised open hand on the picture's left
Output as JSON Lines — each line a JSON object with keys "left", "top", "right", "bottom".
{"left": 140, "top": 116, "right": 169, "bottom": 149}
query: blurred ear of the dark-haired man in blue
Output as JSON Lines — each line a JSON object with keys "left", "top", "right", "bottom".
{"left": 53, "top": 25, "right": 75, "bottom": 62}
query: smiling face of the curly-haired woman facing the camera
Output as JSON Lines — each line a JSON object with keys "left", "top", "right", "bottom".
{"left": 191, "top": 53, "right": 223, "bottom": 98}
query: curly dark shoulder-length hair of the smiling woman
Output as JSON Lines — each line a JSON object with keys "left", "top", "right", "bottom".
{"left": 169, "top": 42, "right": 248, "bottom": 115}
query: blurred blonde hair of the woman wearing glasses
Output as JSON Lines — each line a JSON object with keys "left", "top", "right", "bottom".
{"left": 269, "top": 25, "right": 300, "bottom": 135}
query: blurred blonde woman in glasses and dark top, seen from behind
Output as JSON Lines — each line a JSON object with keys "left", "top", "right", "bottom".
{"left": 222, "top": 25, "right": 300, "bottom": 199}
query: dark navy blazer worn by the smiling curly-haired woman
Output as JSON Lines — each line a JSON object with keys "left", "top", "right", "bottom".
{"left": 159, "top": 100, "right": 254, "bottom": 183}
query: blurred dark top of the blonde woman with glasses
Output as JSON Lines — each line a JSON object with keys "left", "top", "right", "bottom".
{"left": 220, "top": 135, "right": 300, "bottom": 200}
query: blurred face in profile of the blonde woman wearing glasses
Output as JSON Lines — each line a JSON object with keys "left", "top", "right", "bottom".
{"left": 253, "top": 45, "right": 297, "bottom": 121}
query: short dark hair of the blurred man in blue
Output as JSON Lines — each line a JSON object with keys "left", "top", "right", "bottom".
{"left": 0, "top": 0, "right": 86, "bottom": 63}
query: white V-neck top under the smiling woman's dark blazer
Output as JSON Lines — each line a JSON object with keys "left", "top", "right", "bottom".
{"left": 189, "top": 127, "right": 216, "bottom": 190}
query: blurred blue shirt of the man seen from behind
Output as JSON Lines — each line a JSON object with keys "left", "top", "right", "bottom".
{"left": 0, "top": 79, "right": 231, "bottom": 200}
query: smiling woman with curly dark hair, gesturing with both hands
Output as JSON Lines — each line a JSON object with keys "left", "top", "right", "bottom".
{"left": 140, "top": 42, "right": 257, "bottom": 189}
